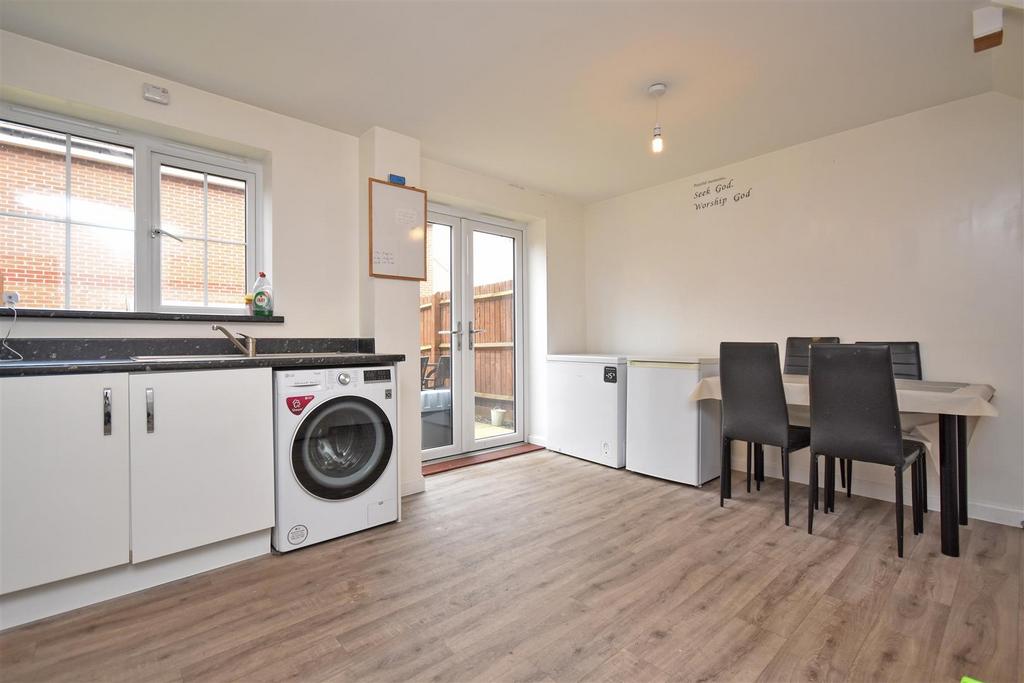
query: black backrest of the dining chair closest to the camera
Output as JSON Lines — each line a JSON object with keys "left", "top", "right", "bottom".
{"left": 809, "top": 344, "right": 903, "bottom": 465}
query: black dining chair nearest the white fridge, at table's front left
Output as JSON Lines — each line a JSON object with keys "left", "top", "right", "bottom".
{"left": 719, "top": 342, "right": 810, "bottom": 526}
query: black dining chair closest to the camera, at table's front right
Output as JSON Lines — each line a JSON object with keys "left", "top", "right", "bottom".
{"left": 807, "top": 344, "right": 925, "bottom": 557}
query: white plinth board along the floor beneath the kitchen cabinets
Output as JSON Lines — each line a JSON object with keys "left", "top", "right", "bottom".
{"left": 0, "top": 529, "right": 270, "bottom": 631}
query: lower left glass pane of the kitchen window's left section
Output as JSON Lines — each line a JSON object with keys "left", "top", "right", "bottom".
{"left": 0, "top": 216, "right": 66, "bottom": 308}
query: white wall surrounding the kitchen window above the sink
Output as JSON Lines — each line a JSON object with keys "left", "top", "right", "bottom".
{"left": 0, "top": 32, "right": 362, "bottom": 342}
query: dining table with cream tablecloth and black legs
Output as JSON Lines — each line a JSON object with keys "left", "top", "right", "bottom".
{"left": 690, "top": 375, "right": 998, "bottom": 557}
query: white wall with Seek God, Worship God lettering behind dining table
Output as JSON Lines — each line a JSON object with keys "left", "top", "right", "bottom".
{"left": 585, "top": 92, "right": 1024, "bottom": 523}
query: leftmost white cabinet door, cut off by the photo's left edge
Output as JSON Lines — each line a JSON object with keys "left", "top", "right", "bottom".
{"left": 0, "top": 374, "right": 129, "bottom": 593}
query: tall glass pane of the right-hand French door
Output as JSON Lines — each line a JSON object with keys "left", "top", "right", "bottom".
{"left": 469, "top": 223, "right": 520, "bottom": 447}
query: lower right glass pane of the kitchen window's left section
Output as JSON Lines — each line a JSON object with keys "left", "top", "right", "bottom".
{"left": 71, "top": 225, "right": 135, "bottom": 310}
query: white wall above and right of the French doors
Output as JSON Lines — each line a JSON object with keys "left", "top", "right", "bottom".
{"left": 423, "top": 159, "right": 586, "bottom": 444}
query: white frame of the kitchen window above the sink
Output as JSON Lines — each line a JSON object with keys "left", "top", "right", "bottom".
{"left": 0, "top": 103, "right": 270, "bottom": 315}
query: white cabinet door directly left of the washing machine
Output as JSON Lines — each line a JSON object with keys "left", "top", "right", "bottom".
{"left": 130, "top": 368, "right": 273, "bottom": 562}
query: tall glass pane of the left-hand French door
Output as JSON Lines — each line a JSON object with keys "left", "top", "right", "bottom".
{"left": 420, "top": 217, "right": 462, "bottom": 460}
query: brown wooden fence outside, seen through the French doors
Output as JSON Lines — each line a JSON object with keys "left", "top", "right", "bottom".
{"left": 420, "top": 280, "right": 515, "bottom": 419}
